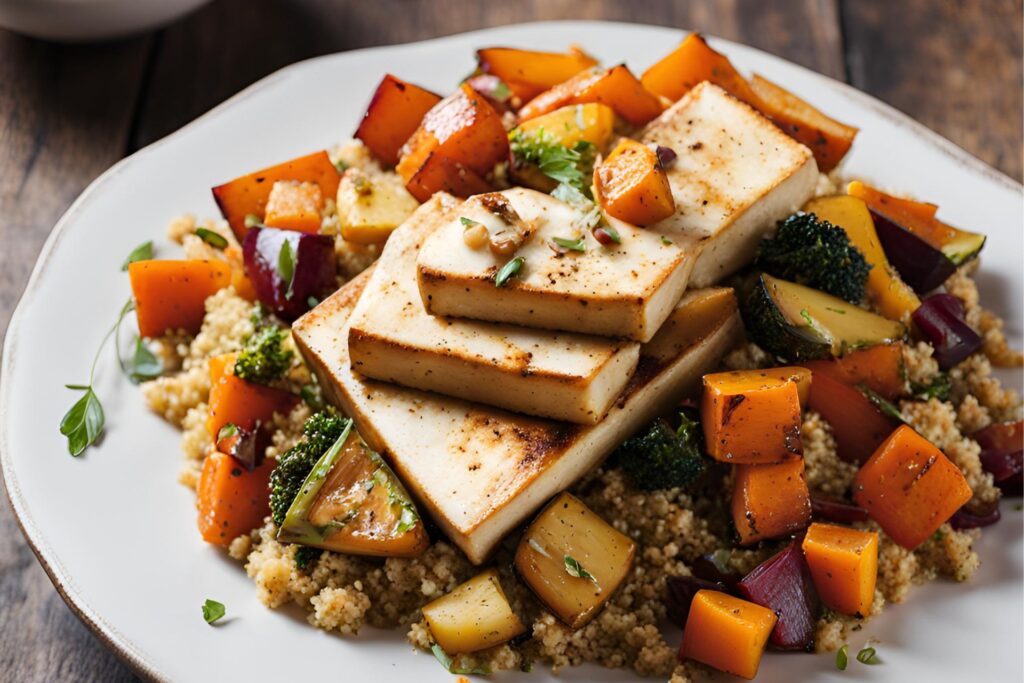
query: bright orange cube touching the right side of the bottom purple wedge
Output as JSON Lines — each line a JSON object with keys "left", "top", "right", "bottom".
{"left": 803, "top": 522, "right": 879, "bottom": 616}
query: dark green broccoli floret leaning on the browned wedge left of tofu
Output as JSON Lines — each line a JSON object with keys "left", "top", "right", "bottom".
{"left": 270, "top": 411, "right": 348, "bottom": 526}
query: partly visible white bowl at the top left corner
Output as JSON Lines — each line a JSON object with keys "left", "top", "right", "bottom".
{"left": 0, "top": 0, "right": 210, "bottom": 42}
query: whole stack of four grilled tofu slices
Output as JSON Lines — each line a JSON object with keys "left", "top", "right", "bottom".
{"left": 293, "top": 83, "right": 818, "bottom": 563}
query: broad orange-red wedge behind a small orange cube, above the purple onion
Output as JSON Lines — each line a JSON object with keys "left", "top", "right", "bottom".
{"left": 213, "top": 152, "right": 341, "bottom": 242}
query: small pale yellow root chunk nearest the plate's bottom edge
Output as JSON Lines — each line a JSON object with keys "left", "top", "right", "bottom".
{"left": 423, "top": 569, "right": 526, "bottom": 653}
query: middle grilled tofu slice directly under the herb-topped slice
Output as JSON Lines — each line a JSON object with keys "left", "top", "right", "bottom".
{"left": 348, "top": 195, "right": 640, "bottom": 424}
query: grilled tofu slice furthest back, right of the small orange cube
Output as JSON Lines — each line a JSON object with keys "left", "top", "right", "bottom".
{"left": 640, "top": 82, "right": 818, "bottom": 287}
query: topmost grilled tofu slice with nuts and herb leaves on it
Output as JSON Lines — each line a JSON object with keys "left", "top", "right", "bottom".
{"left": 417, "top": 187, "right": 693, "bottom": 341}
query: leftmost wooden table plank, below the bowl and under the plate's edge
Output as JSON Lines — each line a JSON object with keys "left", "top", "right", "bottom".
{"left": 0, "top": 26, "right": 150, "bottom": 681}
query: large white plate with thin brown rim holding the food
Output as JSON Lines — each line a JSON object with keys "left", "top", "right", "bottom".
{"left": 0, "top": 23, "right": 1024, "bottom": 683}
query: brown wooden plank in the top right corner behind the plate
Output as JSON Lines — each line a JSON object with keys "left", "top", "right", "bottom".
{"left": 842, "top": 0, "right": 1022, "bottom": 180}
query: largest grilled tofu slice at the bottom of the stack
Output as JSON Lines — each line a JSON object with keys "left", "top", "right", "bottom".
{"left": 292, "top": 273, "right": 741, "bottom": 563}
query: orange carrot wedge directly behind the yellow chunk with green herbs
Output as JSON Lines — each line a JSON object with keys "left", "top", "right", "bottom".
{"left": 519, "top": 65, "right": 665, "bottom": 126}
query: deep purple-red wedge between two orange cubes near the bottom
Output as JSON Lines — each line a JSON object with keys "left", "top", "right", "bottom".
{"left": 736, "top": 541, "right": 821, "bottom": 650}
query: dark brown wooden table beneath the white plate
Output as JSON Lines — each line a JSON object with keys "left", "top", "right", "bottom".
{"left": 0, "top": 0, "right": 1022, "bottom": 681}
